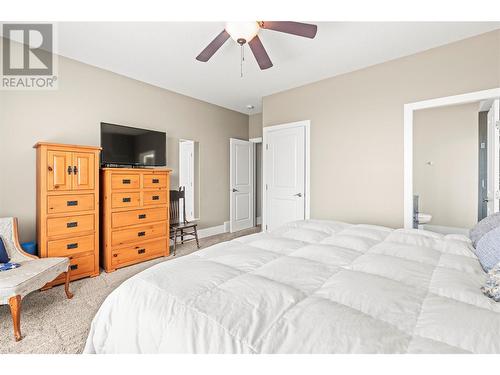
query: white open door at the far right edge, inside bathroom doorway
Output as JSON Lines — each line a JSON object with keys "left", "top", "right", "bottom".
{"left": 487, "top": 99, "right": 500, "bottom": 215}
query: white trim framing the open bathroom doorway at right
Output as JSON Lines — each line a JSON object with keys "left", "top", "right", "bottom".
{"left": 402, "top": 88, "right": 500, "bottom": 228}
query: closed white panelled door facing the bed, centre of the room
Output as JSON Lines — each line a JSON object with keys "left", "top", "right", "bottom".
{"left": 263, "top": 126, "right": 306, "bottom": 231}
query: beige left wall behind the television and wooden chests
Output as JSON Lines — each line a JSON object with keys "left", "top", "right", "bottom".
{"left": 0, "top": 42, "right": 248, "bottom": 241}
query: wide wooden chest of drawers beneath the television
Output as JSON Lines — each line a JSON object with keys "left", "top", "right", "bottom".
{"left": 101, "top": 168, "right": 170, "bottom": 272}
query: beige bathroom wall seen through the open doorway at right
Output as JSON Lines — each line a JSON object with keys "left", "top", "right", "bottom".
{"left": 413, "top": 103, "right": 479, "bottom": 228}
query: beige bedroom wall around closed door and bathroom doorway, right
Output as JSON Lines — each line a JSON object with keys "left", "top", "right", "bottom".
{"left": 263, "top": 30, "right": 500, "bottom": 227}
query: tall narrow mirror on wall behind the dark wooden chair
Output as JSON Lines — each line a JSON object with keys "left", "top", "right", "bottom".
{"left": 179, "top": 140, "right": 195, "bottom": 221}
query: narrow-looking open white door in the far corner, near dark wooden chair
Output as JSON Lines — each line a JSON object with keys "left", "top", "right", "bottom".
{"left": 229, "top": 138, "right": 254, "bottom": 232}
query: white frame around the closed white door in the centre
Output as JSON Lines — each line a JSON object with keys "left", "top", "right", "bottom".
{"left": 262, "top": 120, "right": 311, "bottom": 232}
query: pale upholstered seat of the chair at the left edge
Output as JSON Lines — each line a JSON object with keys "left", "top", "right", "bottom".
{"left": 0, "top": 258, "right": 69, "bottom": 304}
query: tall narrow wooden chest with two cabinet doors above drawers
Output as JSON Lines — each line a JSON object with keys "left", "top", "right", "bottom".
{"left": 34, "top": 142, "right": 100, "bottom": 287}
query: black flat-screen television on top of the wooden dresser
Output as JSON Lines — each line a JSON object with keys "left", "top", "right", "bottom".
{"left": 101, "top": 122, "right": 167, "bottom": 167}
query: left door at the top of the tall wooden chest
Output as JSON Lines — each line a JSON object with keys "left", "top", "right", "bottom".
{"left": 47, "top": 150, "right": 73, "bottom": 191}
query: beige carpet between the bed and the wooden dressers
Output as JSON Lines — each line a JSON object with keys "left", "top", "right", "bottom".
{"left": 0, "top": 227, "right": 260, "bottom": 354}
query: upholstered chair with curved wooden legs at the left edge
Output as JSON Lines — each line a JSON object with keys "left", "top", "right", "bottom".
{"left": 0, "top": 217, "right": 73, "bottom": 341}
